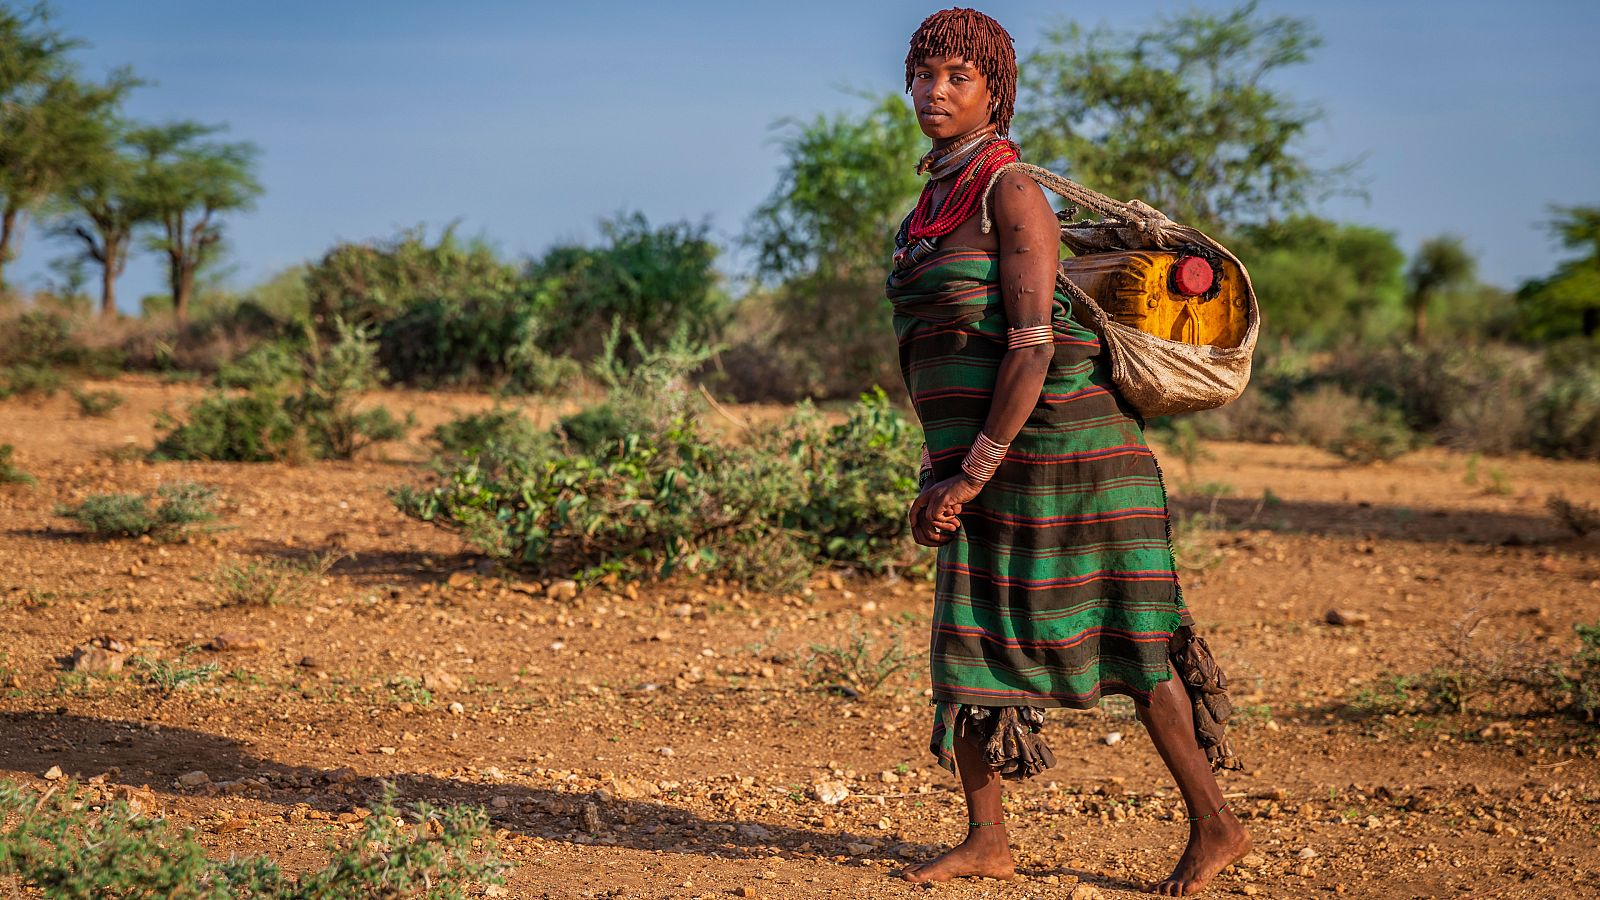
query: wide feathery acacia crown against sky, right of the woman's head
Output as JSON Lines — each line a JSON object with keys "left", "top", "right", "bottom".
{"left": 1014, "top": 2, "right": 1349, "bottom": 226}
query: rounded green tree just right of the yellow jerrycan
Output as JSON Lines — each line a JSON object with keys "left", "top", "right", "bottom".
{"left": 1234, "top": 216, "right": 1405, "bottom": 348}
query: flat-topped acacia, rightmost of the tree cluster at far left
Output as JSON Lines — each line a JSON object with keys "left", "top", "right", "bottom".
{"left": 128, "top": 122, "right": 261, "bottom": 322}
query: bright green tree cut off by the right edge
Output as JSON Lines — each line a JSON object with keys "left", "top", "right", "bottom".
{"left": 1517, "top": 207, "right": 1600, "bottom": 341}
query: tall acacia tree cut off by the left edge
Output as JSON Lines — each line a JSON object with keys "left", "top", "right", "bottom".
{"left": 0, "top": 6, "right": 134, "bottom": 290}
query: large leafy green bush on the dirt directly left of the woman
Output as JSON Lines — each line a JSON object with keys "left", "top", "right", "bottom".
{"left": 394, "top": 336, "right": 915, "bottom": 589}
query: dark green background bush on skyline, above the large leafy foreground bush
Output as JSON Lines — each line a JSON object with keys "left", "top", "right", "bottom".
{"left": 528, "top": 213, "right": 728, "bottom": 356}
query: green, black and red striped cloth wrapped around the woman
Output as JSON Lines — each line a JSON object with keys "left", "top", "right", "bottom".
{"left": 888, "top": 250, "right": 1192, "bottom": 772}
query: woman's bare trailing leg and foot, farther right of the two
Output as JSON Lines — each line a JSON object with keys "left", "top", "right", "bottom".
{"left": 1138, "top": 674, "right": 1250, "bottom": 897}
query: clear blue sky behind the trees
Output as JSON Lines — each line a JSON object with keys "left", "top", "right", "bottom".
{"left": 10, "top": 0, "right": 1600, "bottom": 309}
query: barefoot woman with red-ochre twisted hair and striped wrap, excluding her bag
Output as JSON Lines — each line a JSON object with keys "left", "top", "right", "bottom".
{"left": 888, "top": 10, "right": 1250, "bottom": 897}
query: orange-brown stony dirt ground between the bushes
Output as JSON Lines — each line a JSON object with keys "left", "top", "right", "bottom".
{"left": 0, "top": 378, "right": 1600, "bottom": 898}
